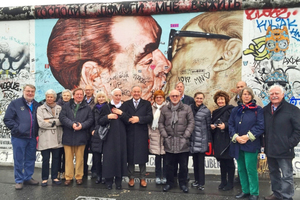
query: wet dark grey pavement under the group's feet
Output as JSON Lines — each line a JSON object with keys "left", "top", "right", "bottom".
{"left": 0, "top": 166, "right": 300, "bottom": 200}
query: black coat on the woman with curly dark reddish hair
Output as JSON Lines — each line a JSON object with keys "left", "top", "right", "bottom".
{"left": 211, "top": 105, "right": 233, "bottom": 159}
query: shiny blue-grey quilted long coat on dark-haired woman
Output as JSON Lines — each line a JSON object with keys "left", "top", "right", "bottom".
{"left": 190, "top": 104, "right": 211, "bottom": 153}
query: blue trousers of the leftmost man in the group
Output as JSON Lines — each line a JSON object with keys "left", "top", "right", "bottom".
{"left": 11, "top": 136, "right": 36, "bottom": 183}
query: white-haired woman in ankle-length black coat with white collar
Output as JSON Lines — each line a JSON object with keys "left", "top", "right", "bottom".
{"left": 95, "top": 88, "right": 129, "bottom": 190}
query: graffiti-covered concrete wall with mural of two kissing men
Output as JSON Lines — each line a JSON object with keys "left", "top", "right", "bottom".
{"left": 0, "top": 1, "right": 300, "bottom": 173}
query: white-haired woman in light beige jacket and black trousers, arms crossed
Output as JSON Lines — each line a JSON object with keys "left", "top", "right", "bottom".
{"left": 37, "top": 89, "right": 63, "bottom": 187}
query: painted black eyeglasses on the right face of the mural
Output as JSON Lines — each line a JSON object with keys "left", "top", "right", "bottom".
{"left": 168, "top": 29, "right": 231, "bottom": 61}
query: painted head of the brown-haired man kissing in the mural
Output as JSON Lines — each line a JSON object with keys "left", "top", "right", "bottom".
{"left": 47, "top": 16, "right": 171, "bottom": 101}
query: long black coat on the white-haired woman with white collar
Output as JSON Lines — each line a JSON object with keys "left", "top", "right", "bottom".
{"left": 96, "top": 104, "right": 128, "bottom": 178}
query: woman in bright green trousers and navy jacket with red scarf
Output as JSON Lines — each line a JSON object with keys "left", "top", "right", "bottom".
{"left": 228, "top": 87, "right": 264, "bottom": 200}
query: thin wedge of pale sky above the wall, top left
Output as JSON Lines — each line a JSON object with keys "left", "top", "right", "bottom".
{"left": 0, "top": 0, "right": 126, "bottom": 7}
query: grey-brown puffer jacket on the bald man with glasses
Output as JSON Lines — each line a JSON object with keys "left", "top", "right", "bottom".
{"left": 158, "top": 101, "right": 195, "bottom": 154}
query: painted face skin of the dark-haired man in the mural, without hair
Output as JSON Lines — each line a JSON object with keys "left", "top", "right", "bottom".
{"left": 81, "top": 17, "right": 171, "bottom": 101}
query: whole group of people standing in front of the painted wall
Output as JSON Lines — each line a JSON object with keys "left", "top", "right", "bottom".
{"left": 4, "top": 81, "right": 300, "bottom": 200}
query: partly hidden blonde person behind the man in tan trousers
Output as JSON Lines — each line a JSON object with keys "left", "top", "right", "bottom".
{"left": 57, "top": 89, "right": 72, "bottom": 179}
